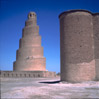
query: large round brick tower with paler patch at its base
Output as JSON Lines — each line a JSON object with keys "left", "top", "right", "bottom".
{"left": 59, "top": 10, "right": 95, "bottom": 82}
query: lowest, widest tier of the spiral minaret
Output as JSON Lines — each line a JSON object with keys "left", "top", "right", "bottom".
{"left": 13, "top": 58, "right": 46, "bottom": 71}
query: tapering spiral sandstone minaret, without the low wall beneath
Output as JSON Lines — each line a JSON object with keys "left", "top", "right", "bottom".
{"left": 13, "top": 12, "right": 46, "bottom": 71}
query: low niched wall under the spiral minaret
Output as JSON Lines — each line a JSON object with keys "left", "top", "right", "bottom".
{"left": 0, "top": 71, "right": 56, "bottom": 78}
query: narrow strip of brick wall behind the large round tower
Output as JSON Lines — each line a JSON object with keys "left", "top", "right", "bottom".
{"left": 93, "top": 13, "right": 99, "bottom": 80}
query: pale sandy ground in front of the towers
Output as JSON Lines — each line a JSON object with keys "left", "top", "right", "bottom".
{"left": 0, "top": 78, "right": 99, "bottom": 99}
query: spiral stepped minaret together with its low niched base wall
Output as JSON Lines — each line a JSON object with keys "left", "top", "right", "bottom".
{"left": 0, "top": 12, "right": 56, "bottom": 78}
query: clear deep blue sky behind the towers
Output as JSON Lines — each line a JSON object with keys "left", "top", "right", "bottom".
{"left": 0, "top": 0, "right": 99, "bottom": 72}
